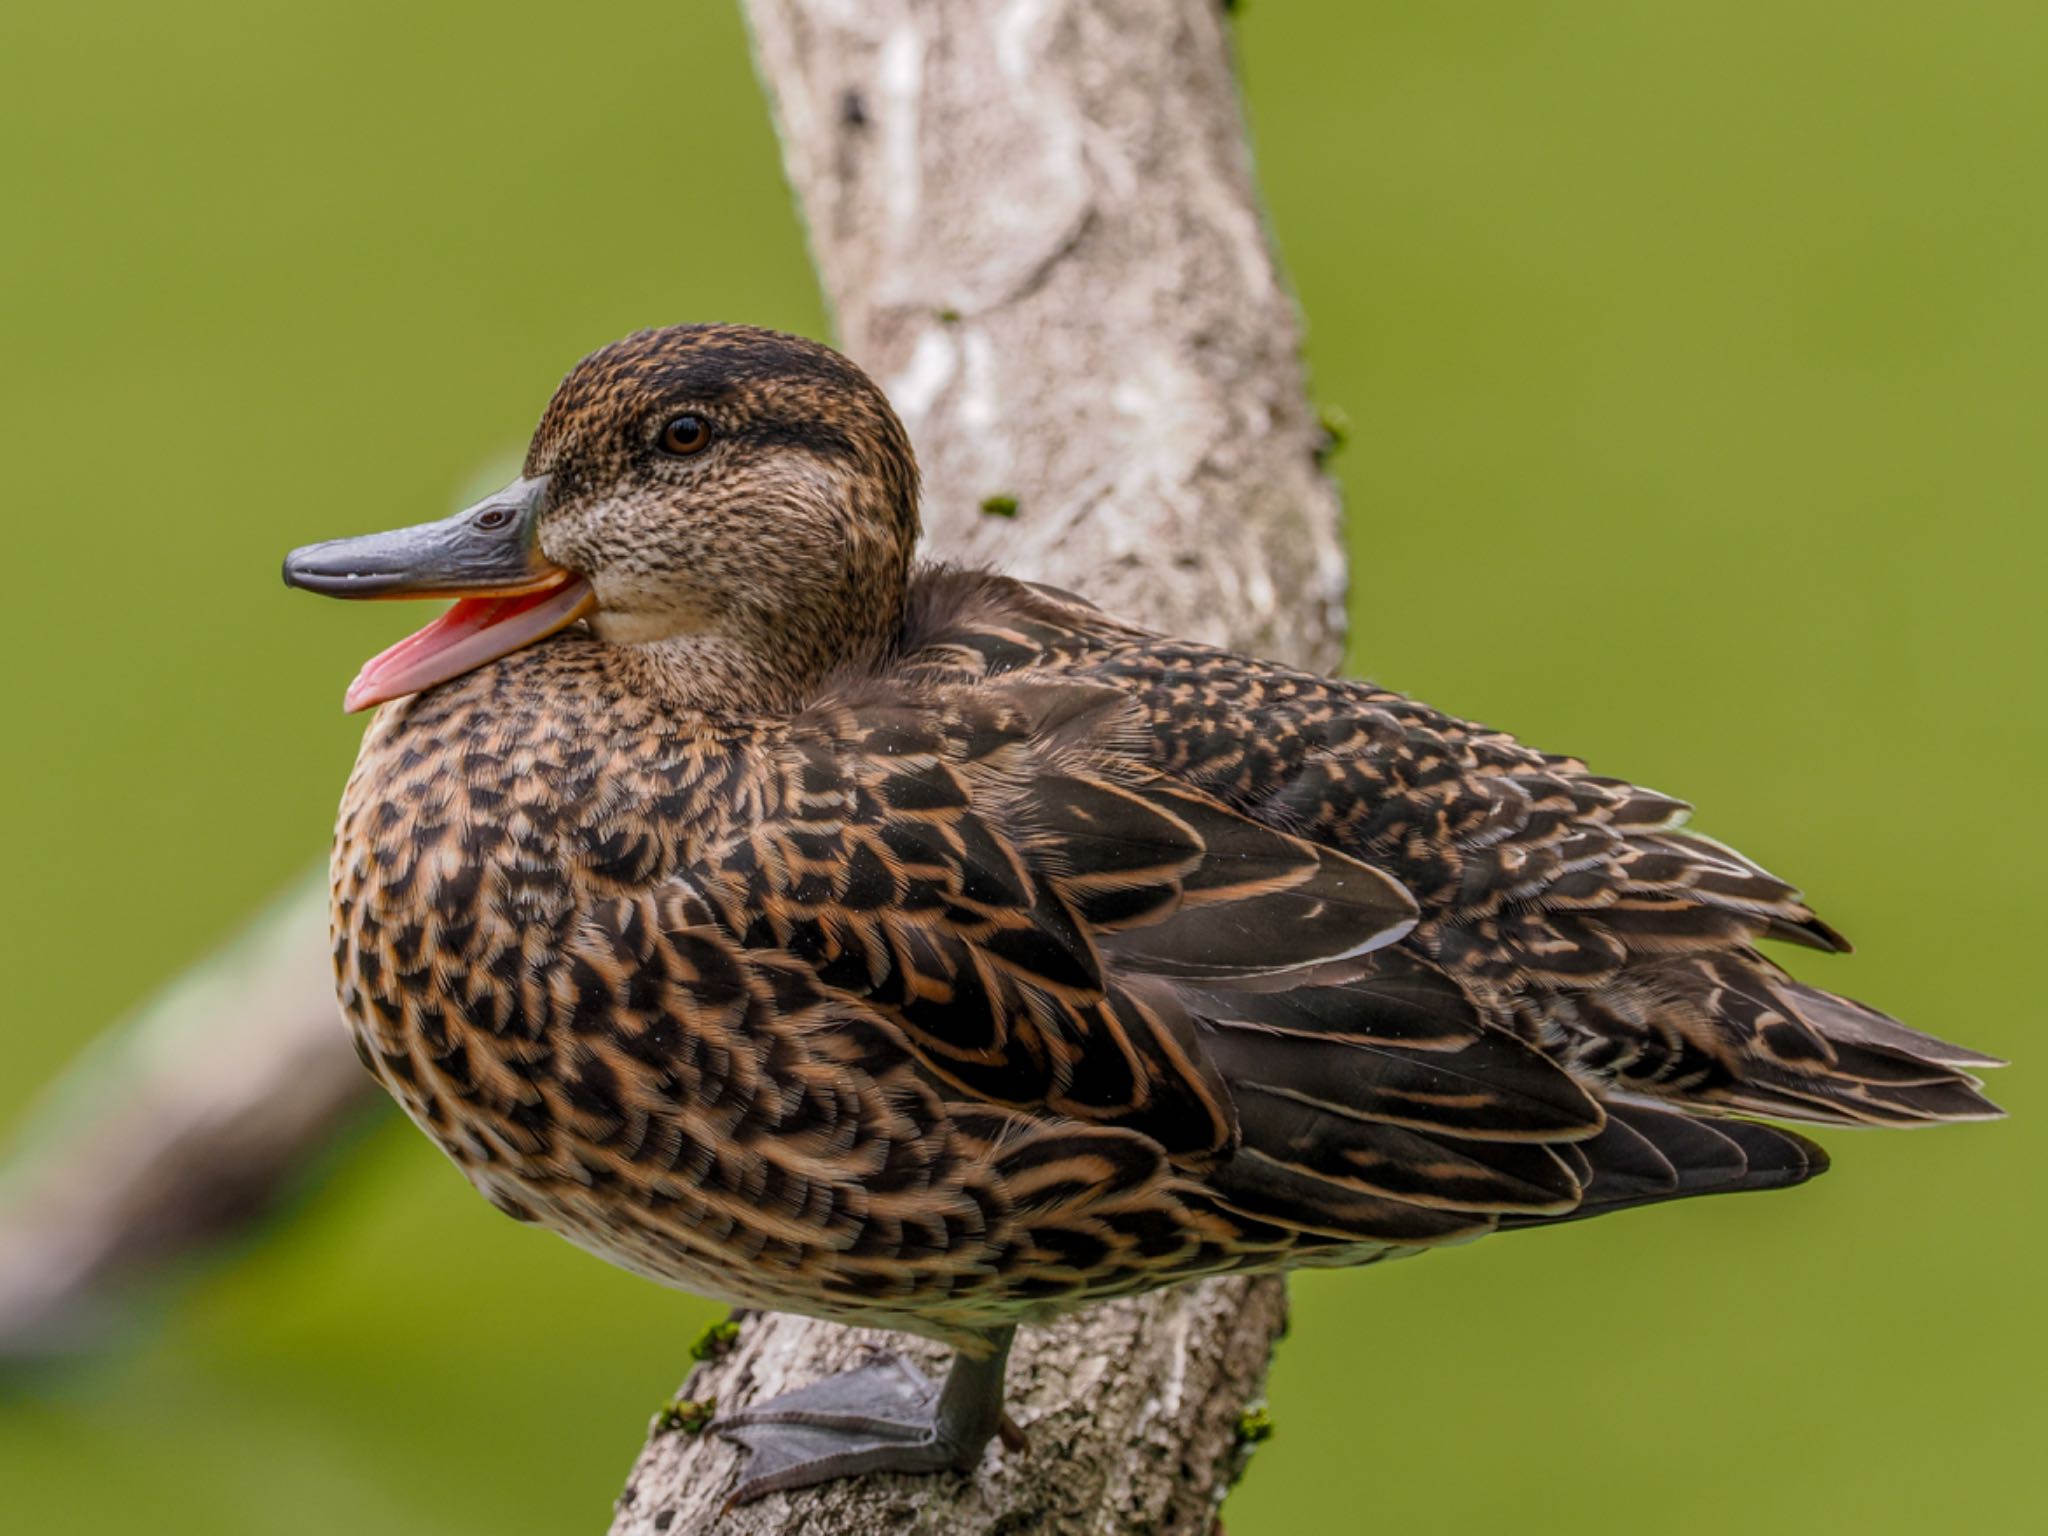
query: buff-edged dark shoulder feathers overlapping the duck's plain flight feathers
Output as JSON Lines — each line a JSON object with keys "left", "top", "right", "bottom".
{"left": 690, "top": 688, "right": 1415, "bottom": 1159}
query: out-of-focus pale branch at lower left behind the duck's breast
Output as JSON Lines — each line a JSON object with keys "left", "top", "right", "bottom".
{"left": 0, "top": 866, "right": 381, "bottom": 1362}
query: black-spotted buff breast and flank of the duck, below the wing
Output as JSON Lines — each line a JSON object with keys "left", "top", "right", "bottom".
{"left": 332, "top": 641, "right": 1056, "bottom": 1335}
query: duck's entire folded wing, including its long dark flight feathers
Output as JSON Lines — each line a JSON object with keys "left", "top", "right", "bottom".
{"left": 667, "top": 680, "right": 1826, "bottom": 1251}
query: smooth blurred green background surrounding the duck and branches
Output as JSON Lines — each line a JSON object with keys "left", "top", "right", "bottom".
{"left": 0, "top": 0, "right": 2048, "bottom": 1536}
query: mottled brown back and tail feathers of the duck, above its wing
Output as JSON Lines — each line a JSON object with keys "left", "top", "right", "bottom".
{"left": 897, "top": 575, "right": 1999, "bottom": 1124}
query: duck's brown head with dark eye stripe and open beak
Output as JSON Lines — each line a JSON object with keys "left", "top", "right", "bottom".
{"left": 285, "top": 326, "right": 918, "bottom": 711}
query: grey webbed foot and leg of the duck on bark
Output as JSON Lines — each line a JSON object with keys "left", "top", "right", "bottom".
{"left": 711, "top": 1327, "right": 1016, "bottom": 1503}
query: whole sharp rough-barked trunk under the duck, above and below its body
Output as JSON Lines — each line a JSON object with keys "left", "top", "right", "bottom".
{"left": 612, "top": 0, "right": 1343, "bottom": 1536}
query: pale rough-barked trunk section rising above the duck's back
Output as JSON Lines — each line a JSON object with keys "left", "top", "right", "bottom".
{"left": 750, "top": 0, "right": 1343, "bottom": 668}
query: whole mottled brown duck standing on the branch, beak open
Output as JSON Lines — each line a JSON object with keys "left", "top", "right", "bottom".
{"left": 285, "top": 324, "right": 2003, "bottom": 1501}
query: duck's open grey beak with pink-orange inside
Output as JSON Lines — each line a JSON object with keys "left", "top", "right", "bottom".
{"left": 285, "top": 475, "right": 596, "bottom": 715}
